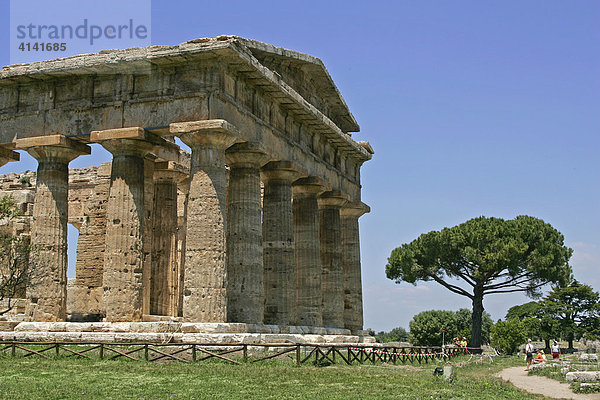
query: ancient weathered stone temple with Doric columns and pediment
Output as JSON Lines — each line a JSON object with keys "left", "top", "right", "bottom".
{"left": 0, "top": 36, "right": 373, "bottom": 342}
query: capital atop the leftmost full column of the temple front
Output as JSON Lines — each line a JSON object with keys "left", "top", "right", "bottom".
{"left": 15, "top": 135, "right": 92, "bottom": 164}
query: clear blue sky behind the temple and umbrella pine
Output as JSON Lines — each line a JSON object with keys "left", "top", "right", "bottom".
{"left": 0, "top": 0, "right": 600, "bottom": 330}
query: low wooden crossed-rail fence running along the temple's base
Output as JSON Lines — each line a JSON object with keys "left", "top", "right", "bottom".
{"left": 0, "top": 341, "right": 463, "bottom": 366}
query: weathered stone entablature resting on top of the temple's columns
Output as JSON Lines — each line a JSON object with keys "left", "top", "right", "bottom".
{"left": 0, "top": 36, "right": 371, "bottom": 198}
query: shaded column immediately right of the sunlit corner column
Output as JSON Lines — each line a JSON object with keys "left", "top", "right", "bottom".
{"left": 225, "top": 142, "right": 269, "bottom": 324}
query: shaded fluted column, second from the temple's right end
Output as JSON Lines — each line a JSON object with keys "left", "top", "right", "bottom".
{"left": 319, "top": 190, "right": 348, "bottom": 328}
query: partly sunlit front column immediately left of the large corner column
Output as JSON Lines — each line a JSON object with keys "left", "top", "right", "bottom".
{"left": 96, "top": 139, "right": 153, "bottom": 321}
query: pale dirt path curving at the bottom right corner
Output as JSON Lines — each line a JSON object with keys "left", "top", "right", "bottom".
{"left": 498, "top": 367, "right": 600, "bottom": 400}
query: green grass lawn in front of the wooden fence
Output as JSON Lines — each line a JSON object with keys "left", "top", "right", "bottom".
{"left": 0, "top": 356, "right": 540, "bottom": 399}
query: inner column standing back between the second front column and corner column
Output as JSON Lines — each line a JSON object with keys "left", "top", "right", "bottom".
{"left": 150, "top": 162, "right": 187, "bottom": 316}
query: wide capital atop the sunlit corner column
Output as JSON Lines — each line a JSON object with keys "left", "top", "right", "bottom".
{"left": 169, "top": 119, "right": 240, "bottom": 150}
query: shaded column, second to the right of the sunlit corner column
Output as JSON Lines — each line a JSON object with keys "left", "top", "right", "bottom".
{"left": 262, "top": 161, "right": 306, "bottom": 325}
